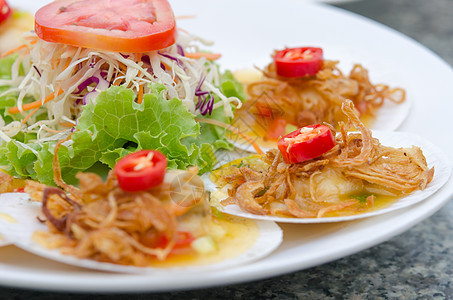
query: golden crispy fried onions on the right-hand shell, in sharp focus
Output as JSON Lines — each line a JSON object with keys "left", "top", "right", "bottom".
{"left": 218, "top": 100, "right": 434, "bottom": 218}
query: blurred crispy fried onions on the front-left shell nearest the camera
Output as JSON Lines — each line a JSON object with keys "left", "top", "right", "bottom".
{"left": 32, "top": 141, "right": 205, "bottom": 266}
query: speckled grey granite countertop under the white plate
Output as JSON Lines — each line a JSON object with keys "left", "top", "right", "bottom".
{"left": 0, "top": 0, "right": 453, "bottom": 299}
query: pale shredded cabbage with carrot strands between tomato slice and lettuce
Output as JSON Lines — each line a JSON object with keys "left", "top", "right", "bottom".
{"left": 0, "top": 31, "right": 242, "bottom": 143}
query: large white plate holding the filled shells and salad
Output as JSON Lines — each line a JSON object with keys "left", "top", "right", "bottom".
{"left": 0, "top": 0, "right": 453, "bottom": 292}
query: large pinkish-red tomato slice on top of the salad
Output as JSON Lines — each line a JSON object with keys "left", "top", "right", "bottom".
{"left": 35, "top": 0, "right": 176, "bottom": 53}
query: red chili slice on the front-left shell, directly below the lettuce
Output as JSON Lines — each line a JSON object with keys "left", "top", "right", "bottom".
{"left": 114, "top": 150, "right": 167, "bottom": 192}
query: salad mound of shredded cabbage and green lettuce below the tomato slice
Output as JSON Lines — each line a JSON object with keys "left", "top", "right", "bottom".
{"left": 0, "top": 1, "right": 244, "bottom": 184}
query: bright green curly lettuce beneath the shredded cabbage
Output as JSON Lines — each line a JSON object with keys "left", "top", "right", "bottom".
{"left": 0, "top": 66, "right": 245, "bottom": 185}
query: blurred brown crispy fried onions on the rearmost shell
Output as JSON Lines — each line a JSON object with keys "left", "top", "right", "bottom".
{"left": 237, "top": 60, "right": 406, "bottom": 127}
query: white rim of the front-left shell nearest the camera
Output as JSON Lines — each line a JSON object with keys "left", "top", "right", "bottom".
{"left": 0, "top": 193, "right": 283, "bottom": 274}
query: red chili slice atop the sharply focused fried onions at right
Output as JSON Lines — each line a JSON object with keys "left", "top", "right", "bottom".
{"left": 277, "top": 124, "right": 335, "bottom": 164}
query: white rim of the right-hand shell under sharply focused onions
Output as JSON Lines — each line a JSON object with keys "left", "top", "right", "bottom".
{"left": 207, "top": 131, "right": 452, "bottom": 224}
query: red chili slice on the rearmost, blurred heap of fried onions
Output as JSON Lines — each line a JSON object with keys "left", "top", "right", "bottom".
{"left": 274, "top": 47, "right": 323, "bottom": 77}
